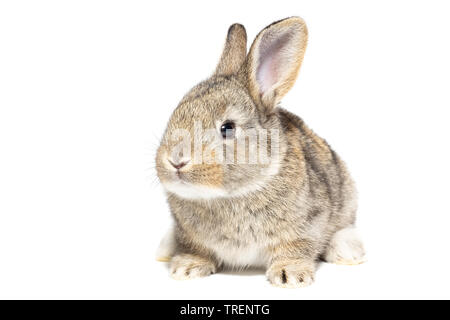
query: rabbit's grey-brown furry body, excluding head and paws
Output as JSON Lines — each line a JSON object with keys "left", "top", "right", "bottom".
{"left": 169, "top": 108, "right": 356, "bottom": 268}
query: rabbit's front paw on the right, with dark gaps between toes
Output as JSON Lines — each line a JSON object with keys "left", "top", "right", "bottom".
{"left": 266, "top": 261, "right": 315, "bottom": 288}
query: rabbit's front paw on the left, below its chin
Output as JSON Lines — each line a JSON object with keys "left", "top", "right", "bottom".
{"left": 170, "top": 254, "right": 216, "bottom": 280}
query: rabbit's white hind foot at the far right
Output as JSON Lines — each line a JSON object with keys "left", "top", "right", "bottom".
{"left": 324, "top": 227, "right": 366, "bottom": 265}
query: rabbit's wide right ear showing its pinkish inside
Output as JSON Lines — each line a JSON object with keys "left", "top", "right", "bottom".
{"left": 245, "top": 17, "right": 308, "bottom": 110}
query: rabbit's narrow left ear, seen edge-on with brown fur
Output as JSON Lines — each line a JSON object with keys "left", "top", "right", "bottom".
{"left": 214, "top": 23, "right": 247, "bottom": 76}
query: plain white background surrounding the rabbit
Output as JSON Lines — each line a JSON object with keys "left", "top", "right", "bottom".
{"left": 0, "top": 0, "right": 450, "bottom": 299}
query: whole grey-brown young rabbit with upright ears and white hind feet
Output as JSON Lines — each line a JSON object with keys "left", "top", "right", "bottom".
{"left": 156, "top": 17, "right": 365, "bottom": 288}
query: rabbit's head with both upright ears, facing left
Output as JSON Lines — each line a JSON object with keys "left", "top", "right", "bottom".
{"left": 156, "top": 17, "right": 307, "bottom": 199}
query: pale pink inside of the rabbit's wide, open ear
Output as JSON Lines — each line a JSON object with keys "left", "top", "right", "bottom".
{"left": 256, "top": 32, "right": 291, "bottom": 94}
